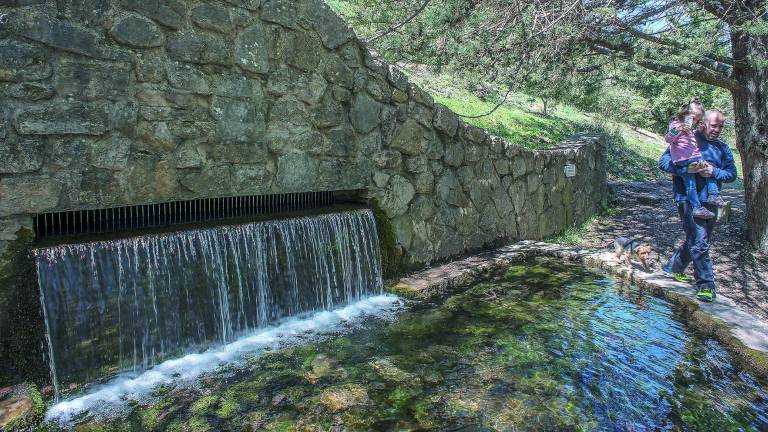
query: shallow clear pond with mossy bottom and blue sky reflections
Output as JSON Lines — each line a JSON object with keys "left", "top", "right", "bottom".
{"left": 47, "top": 260, "right": 768, "bottom": 431}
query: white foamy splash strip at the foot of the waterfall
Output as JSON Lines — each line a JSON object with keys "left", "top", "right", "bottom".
{"left": 46, "top": 294, "right": 403, "bottom": 424}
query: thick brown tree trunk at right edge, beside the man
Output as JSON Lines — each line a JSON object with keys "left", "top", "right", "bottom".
{"left": 732, "top": 37, "right": 768, "bottom": 253}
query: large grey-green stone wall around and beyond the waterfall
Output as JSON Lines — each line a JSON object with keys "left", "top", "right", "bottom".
{"left": 0, "top": 0, "right": 605, "bottom": 384}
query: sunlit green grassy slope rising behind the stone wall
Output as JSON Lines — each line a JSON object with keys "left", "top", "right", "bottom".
{"left": 405, "top": 67, "right": 666, "bottom": 181}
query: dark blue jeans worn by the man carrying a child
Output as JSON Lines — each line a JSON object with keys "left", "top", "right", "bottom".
{"left": 664, "top": 201, "right": 717, "bottom": 289}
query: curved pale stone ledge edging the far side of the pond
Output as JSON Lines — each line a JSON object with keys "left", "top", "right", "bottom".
{"left": 387, "top": 241, "right": 768, "bottom": 379}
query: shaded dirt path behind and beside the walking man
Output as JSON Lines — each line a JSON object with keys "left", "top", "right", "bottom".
{"left": 580, "top": 181, "right": 768, "bottom": 320}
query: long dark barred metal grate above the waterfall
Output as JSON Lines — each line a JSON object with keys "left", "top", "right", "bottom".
{"left": 34, "top": 192, "right": 336, "bottom": 239}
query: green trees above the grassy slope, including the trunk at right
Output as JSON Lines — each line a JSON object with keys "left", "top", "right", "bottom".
{"left": 334, "top": 0, "right": 768, "bottom": 252}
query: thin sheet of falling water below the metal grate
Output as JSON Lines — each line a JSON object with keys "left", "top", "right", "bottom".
{"left": 34, "top": 210, "right": 383, "bottom": 394}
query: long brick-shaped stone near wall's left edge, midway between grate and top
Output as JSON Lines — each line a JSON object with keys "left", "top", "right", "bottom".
{"left": 15, "top": 103, "right": 109, "bottom": 135}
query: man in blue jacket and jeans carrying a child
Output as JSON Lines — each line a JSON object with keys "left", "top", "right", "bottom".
{"left": 659, "top": 110, "right": 736, "bottom": 302}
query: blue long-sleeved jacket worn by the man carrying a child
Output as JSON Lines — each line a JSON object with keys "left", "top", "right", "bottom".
{"left": 659, "top": 131, "right": 736, "bottom": 202}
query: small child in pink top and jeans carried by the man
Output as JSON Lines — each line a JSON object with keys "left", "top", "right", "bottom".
{"left": 665, "top": 99, "right": 725, "bottom": 219}
